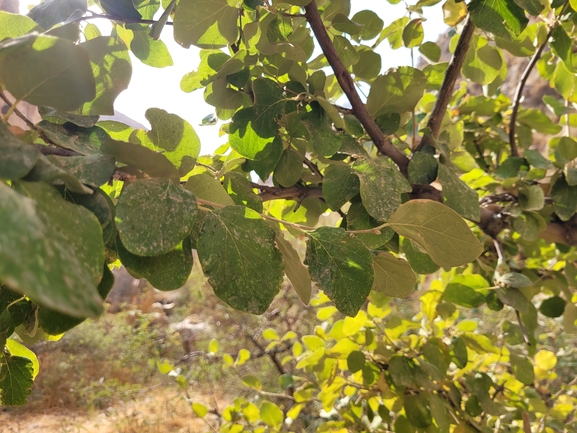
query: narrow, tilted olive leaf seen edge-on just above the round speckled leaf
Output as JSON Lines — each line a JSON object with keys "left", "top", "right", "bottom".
{"left": 100, "top": 139, "right": 180, "bottom": 179}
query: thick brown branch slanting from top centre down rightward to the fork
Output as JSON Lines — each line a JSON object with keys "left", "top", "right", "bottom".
{"left": 305, "top": 0, "right": 409, "bottom": 175}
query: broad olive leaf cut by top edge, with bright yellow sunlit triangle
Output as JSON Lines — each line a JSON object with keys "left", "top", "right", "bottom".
{"left": 174, "top": 0, "right": 238, "bottom": 48}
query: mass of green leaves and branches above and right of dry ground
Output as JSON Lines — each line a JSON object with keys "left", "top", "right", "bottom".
{"left": 0, "top": 0, "right": 577, "bottom": 431}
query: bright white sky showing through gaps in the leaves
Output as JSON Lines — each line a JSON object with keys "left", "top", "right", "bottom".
{"left": 20, "top": 0, "right": 447, "bottom": 154}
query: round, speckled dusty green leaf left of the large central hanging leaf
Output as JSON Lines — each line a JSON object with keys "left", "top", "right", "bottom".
{"left": 116, "top": 179, "right": 197, "bottom": 256}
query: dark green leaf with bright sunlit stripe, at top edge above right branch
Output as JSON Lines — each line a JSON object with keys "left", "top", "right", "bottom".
{"left": 468, "top": 0, "right": 529, "bottom": 39}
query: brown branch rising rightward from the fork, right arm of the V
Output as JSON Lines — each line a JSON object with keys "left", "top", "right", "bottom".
{"left": 414, "top": 18, "right": 475, "bottom": 152}
